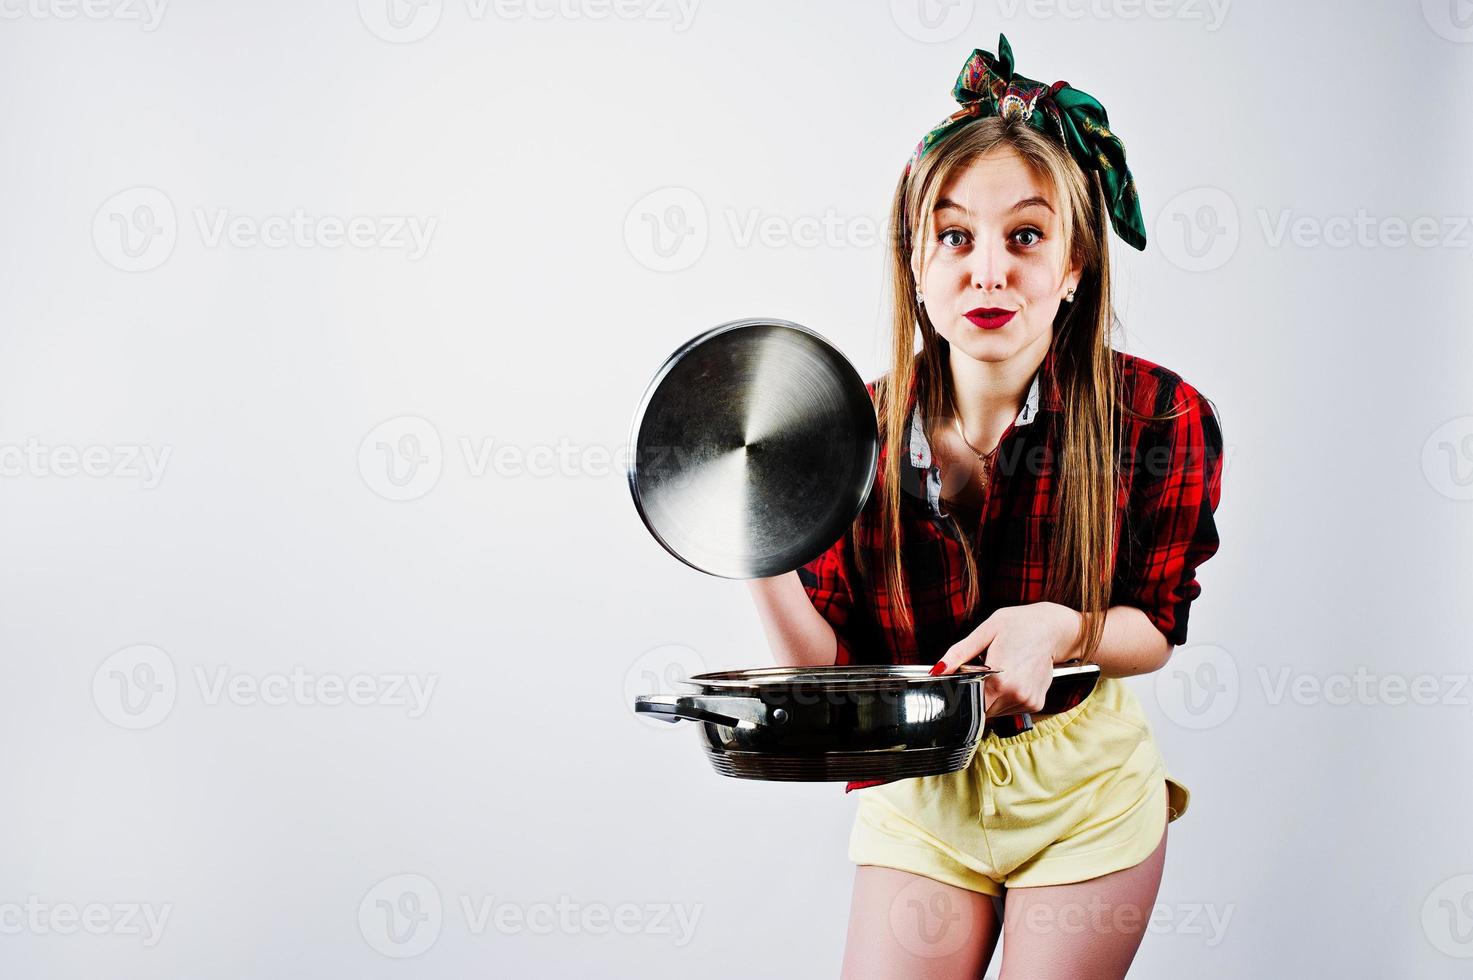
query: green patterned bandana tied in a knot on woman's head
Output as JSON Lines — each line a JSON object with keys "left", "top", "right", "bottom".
{"left": 906, "top": 34, "right": 1146, "bottom": 251}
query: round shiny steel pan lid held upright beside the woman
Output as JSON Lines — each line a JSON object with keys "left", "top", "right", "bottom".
{"left": 629, "top": 318, "right": 879, "bottom": 579}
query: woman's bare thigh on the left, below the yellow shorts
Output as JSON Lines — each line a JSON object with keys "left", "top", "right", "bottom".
{"left": 843, "top": 865, "right": 1000, "bottom": 980}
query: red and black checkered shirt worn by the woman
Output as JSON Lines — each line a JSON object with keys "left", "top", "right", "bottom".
{"left": 798, "top": 351, "right": 1223, "bottom": 791}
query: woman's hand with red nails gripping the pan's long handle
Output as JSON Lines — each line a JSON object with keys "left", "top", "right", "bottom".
{"left": 932, "top": 603, "right": 1080, "bottom": 716}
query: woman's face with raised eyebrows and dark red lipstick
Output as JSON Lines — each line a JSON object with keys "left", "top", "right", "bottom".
{"left": 916, "top": 147, "right": 1080, "bottom": 363}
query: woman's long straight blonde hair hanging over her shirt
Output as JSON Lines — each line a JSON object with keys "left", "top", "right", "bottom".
{"left": 853, "top": 116, "right": 1178, "bottom": 662}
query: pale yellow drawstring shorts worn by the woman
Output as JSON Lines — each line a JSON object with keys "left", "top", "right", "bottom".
{"left": 848, "top": 676, "right": 1190, "bottom": 895}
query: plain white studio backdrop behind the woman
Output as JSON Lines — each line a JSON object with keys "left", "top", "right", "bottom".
{"left": 0, "top": 0, "right": 1473, "bottom": 979}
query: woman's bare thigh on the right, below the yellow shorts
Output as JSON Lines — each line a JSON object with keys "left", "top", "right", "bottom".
{"left": 1002, "top": 795, "right": 1167, "bottom": 980}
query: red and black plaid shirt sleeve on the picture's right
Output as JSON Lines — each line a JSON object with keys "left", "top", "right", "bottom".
{"left": 1111, "top": 382, "right": 1223, "bottom": 645}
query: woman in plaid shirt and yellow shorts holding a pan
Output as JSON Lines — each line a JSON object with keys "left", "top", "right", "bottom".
{"left": 751, "top": 38, "right": 1223, "bottom": 980}
